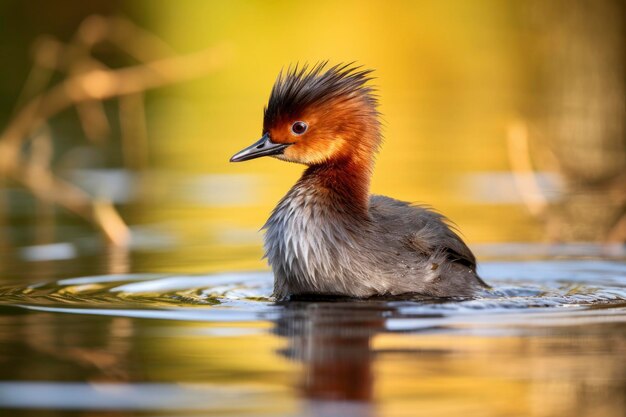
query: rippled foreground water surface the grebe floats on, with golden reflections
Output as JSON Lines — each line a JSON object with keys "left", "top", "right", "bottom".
{"left": 0, "top": 259, "right": 626, "bottom": 416}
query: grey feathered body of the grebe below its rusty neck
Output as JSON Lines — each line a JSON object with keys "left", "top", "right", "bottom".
{"left": 265, "top": 176, "right": 485, "bottom": 299}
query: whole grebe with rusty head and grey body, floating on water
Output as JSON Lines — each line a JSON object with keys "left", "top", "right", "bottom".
{"left": 233, "top": 65, "right": 486, "bottom": 299}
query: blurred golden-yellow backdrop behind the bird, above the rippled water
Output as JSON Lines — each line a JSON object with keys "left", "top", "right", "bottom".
{"left": 1, "top": 0, "right": 626, "bottom": 276}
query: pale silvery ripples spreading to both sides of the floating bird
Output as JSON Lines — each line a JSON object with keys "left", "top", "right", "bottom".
{"left": 0, "top": 260, "right": 626, "bottom": 331}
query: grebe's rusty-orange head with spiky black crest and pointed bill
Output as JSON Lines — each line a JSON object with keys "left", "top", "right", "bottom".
{"left": 231, "top": 63, "right": 381, "bottom": 166}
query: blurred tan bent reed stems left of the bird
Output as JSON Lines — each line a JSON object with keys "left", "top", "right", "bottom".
{"left": 0, "top": 16, "right": 227, "bottom": 246}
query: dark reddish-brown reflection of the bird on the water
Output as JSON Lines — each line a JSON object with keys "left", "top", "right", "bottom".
{"left": 275, "top": 302, "right": 382, "bottom": 401}
